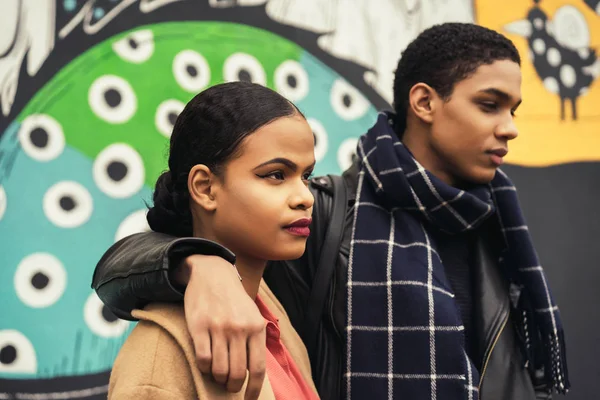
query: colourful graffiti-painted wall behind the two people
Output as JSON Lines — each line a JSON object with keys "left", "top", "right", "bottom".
{"left": 0, "top": 0, "right": 600, "bottom": 399}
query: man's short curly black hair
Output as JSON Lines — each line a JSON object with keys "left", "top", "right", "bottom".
{"left": 394, "top": 23, "right": 521, "bottom": 136}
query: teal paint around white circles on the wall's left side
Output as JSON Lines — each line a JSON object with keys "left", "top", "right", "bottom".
{"left": 0, "top": 126, "right": 143, "bottom": 378}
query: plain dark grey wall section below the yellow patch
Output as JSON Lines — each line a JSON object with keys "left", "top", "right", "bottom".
{"left": 503, "top": 163, "right": 600, "bottom": 400}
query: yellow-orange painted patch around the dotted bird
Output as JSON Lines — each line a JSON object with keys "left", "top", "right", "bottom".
{"left": 475, "top": 0, "right": 600, "bottom": 166}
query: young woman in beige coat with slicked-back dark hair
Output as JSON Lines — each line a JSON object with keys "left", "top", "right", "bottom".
{"left": 108, "top": 82, "right": 318, "bottom": 400}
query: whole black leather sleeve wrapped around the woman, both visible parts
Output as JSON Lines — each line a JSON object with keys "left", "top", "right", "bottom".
{"left": 92, "top": 178, "right": 332, "bottom": 322}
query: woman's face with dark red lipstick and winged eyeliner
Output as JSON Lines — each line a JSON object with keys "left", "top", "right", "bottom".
{"left": 204, "top": 115, "right": 315, "bottom": 260}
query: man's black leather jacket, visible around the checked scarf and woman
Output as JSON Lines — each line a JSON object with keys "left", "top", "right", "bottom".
{"left": 92, "top": 164, "right": 551, "bottom": 400}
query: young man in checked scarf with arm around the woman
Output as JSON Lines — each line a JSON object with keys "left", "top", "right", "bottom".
{"left": 93, "top": 23, "right": 569, "bottom": 400}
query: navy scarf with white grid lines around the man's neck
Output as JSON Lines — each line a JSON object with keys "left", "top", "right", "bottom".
{"left": 345, "top": 113, "right": 569, "bottom": 400}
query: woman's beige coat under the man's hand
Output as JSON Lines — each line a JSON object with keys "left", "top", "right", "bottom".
{"left": 108, "top": 281, "right": 316, "bottom": 400}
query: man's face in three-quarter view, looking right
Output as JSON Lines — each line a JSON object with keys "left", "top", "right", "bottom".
{"left": 427, "top": 60, "right": 521, "bottom": 185}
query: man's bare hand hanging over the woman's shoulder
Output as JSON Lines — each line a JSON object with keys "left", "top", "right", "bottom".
{"left": 175, "top": 255, "right": 266, "bottom": 400}
